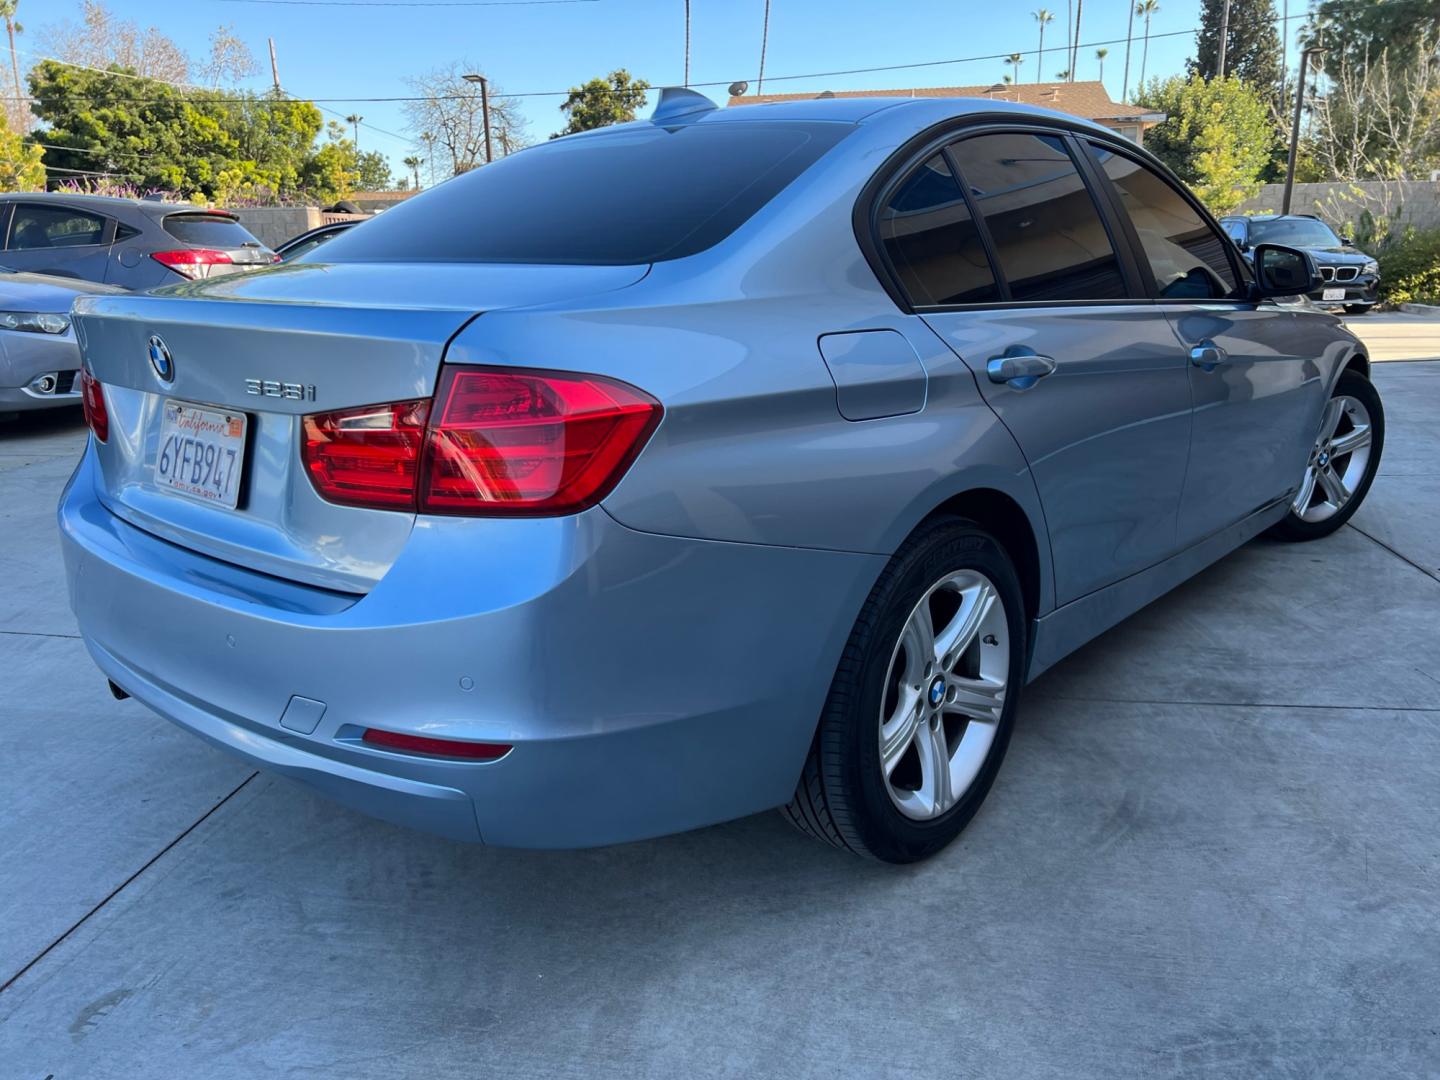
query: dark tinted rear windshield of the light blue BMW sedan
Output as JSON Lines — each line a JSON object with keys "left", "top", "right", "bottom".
{"left": 318, "top": 122, "right": 854, "bottom": 265}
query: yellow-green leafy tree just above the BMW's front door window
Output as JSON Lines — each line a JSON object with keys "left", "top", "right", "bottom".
{"left": 1135, "top": 75, "right": 1277, "bottom": 215}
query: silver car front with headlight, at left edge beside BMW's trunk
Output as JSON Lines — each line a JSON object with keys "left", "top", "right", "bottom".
{"left": 0, "top": 266, "right": 121, "bottom": 416}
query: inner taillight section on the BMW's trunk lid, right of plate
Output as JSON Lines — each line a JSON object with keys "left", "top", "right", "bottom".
{"left": 301, "top": 399, "right": 431, "bottom": 510}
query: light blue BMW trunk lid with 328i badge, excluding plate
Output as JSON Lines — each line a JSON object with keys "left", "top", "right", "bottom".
{"left": 75, "top": 264, "right": 647, "bottom": 592}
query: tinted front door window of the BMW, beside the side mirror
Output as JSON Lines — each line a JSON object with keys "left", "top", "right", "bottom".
{"left": 1086, "top": 143, "right": 1238, "bottom": 300}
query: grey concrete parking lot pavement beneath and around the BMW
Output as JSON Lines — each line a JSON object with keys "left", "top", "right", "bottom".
{"left": 0, "top": 360, "right": 1440, "bottom": 1080}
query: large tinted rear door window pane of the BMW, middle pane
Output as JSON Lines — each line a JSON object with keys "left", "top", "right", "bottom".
{"left": 952, "top": 132, "right": 1128, "bottom": 302}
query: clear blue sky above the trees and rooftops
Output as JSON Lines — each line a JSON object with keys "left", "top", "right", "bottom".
{"left": 19, "top": 0, "right": 1306, "bottom": 173}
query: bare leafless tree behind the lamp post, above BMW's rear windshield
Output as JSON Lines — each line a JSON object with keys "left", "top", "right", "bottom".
{"left": 405, "top": 60, "right": 530, "bottom": 176}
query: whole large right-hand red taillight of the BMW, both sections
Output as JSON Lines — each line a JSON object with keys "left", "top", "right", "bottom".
{"left": 301, "top": 367, "right": 662, "bottom": 517}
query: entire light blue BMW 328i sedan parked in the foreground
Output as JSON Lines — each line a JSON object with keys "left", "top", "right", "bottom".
{"left": 59, "top": 91, "right": 1384, "bottom": 863}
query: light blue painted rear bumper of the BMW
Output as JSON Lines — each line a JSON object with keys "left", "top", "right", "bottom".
{"left": 59, "top": 449, "right": 884, "bottom": 847}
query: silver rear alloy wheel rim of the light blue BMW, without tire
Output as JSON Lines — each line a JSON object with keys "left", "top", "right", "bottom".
{"left": 880, "top": 570, "right": 1009, "bottom": 821}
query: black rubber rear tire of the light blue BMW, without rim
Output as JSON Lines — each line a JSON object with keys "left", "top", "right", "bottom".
{"left": 782, "top": 516, "right": 1028, "bottom": 863}
